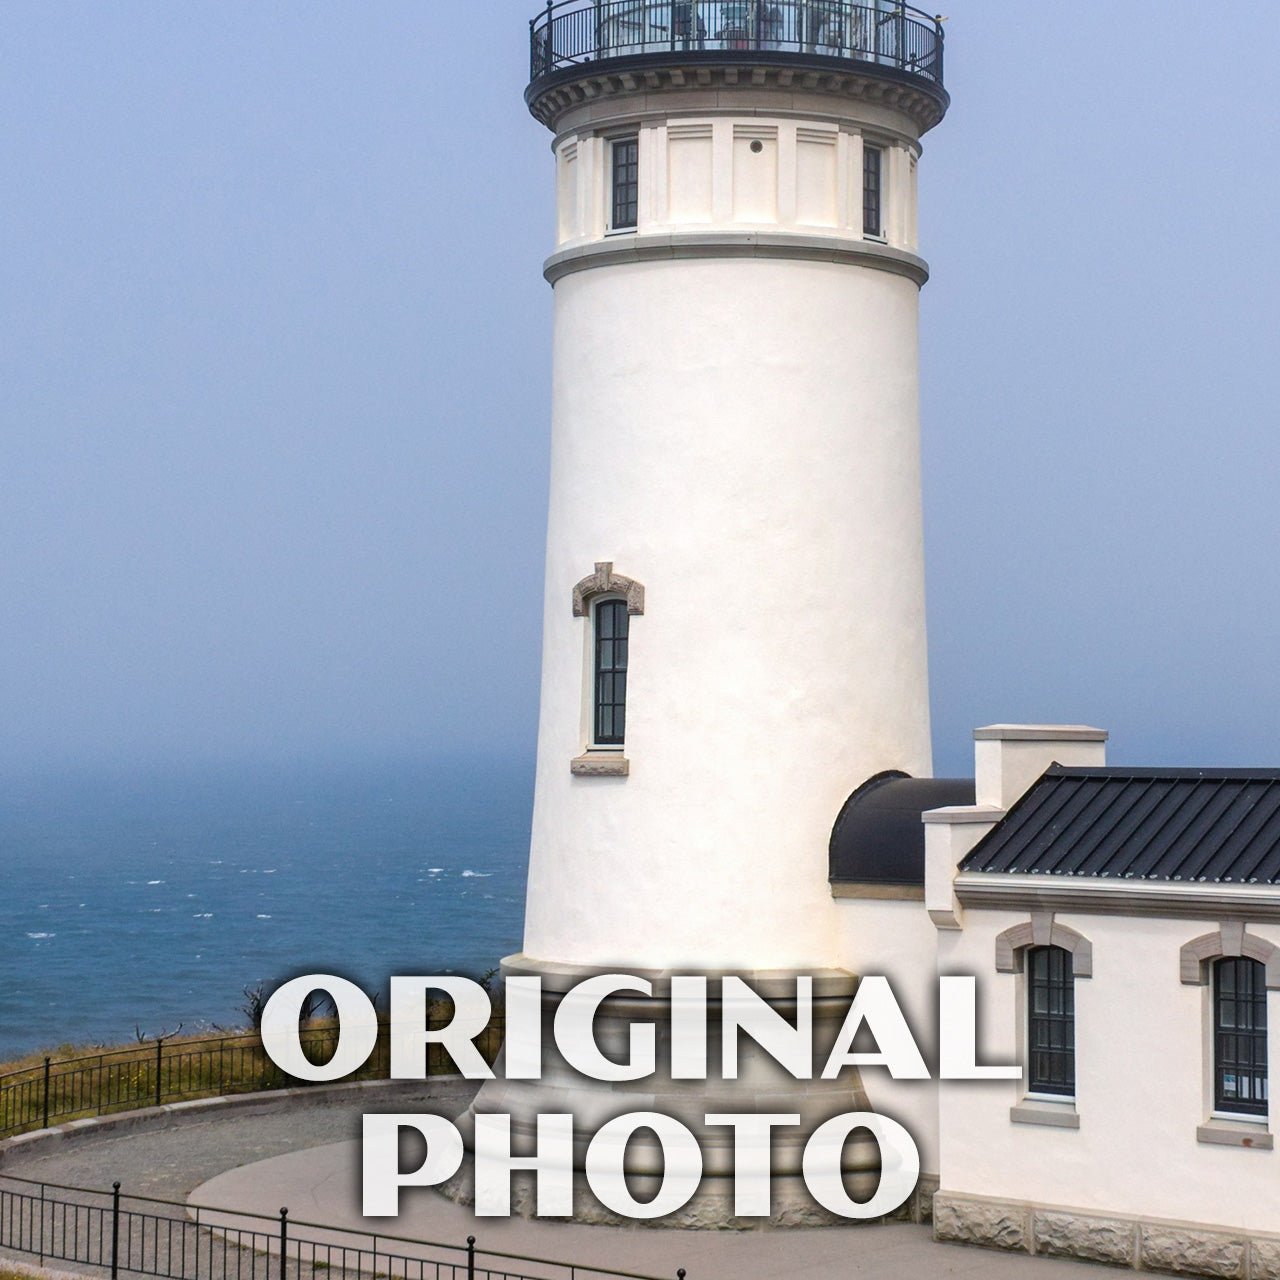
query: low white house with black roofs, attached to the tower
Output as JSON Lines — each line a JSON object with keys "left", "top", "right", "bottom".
{"left": 831, "top": 726, "right": 1280, "bottom": 1280}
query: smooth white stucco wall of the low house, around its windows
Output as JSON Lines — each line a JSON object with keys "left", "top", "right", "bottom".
{"left": 938, "top": 910, "right": 1280, "bottom": 1231}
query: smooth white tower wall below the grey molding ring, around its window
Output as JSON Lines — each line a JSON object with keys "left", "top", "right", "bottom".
{"left": 525, "top": 252, "right": 929, "bottom": 969}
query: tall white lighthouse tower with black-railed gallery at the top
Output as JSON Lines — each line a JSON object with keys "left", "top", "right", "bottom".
{"left": 465, "top": 0, "right": 948, "bottom": 1220}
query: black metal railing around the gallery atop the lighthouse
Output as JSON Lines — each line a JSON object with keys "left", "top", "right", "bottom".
{"left": 530, "top": 0, "right": 943, "bottom": 84}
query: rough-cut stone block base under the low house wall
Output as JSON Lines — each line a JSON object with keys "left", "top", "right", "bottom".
{"left": 933, "top": 1192, "right": 1280, "bottom": 1280}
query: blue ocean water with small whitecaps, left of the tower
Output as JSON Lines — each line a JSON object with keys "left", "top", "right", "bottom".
{"left": 0, "top": 760, "right": 534, "bottom": 1057}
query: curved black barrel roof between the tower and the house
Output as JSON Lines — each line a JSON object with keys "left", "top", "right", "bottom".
{"left": 828, "top": 772, "right": 974, "bottom": 884}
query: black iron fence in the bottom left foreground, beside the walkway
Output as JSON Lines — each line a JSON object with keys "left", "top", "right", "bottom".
{"left": 0, "top": 1175, "right": 685, "bottom": 1280}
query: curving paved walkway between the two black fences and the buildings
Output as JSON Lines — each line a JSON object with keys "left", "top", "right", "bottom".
{"left": 3, "top": 1080, "right": 1116, "bottom": 1280}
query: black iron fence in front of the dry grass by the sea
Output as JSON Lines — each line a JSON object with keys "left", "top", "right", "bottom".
{"left": 0, "top": 1015, "right": 503, "bottom": 1138}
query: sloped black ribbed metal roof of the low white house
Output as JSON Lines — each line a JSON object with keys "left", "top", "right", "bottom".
{"left": 960, "top": 764, "right": 1280, "bottom": 884}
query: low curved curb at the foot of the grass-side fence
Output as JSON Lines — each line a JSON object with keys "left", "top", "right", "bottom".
{"left": 0, "top": 1075, "right": 462, "bottom": 1169}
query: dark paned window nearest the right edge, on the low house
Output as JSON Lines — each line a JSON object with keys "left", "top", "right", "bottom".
{"left": 1213, "top": 956, "right": 1267, "bottom": 1116}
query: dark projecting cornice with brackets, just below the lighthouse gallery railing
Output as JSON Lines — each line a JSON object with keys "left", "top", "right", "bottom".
{"left": 525, "top": 51, "right": 950, "bottom": 138}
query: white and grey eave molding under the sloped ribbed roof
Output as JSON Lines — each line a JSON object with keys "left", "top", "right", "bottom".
{"left": 955, "top": 872, "right": 1280, "bottom": 923}
